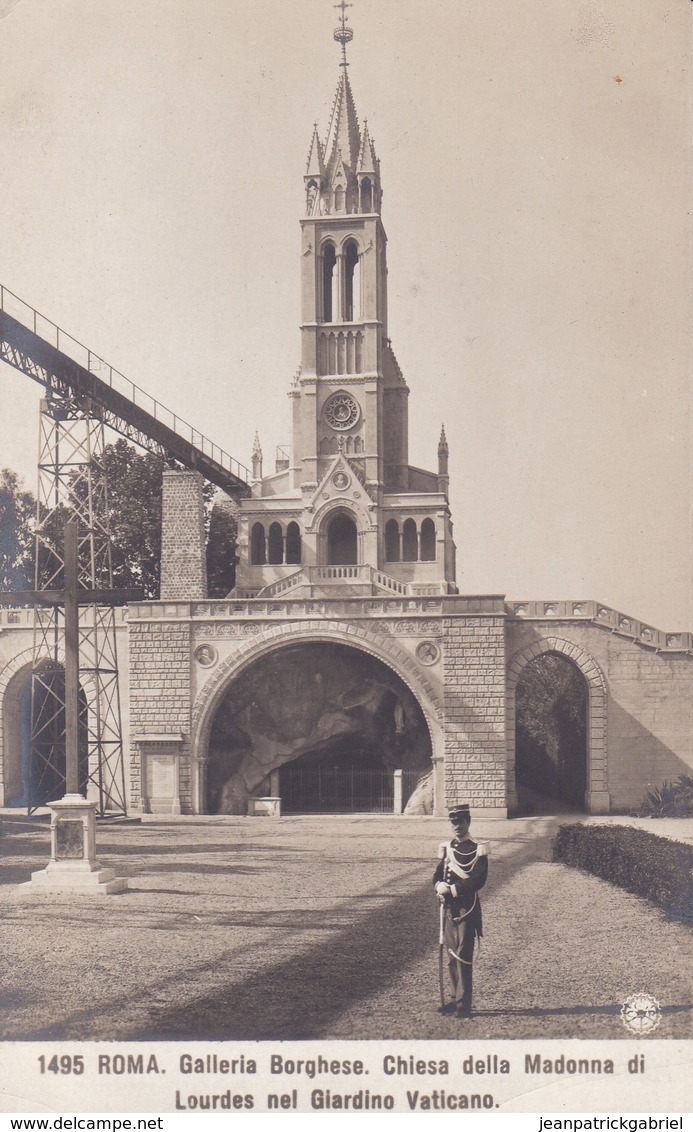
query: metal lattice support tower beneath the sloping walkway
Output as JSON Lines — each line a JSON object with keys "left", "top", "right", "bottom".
{"left": 28, "top": 392, "right": 127, "bottom": 816}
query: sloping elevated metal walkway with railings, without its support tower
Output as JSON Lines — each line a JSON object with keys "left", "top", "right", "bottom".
{"left": 0, "top": 285, "right": 250, "bottom": 497}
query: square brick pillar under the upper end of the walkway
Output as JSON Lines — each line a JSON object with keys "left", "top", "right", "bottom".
{"left": 161, "top": 470, "right": 207, "bottom": 601}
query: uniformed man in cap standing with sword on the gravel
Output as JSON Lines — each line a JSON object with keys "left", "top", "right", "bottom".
{"left": 434, "top": 805, "right": 488, "bottom": 1018}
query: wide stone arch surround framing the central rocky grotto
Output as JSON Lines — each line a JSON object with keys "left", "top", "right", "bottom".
{"left": 191, "top": 621, "right": 445, "bottom": 813}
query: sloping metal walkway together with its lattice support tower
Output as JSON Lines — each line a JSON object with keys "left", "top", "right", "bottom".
{"left": 0, "top": 285, "right": 250, "bottom": 816}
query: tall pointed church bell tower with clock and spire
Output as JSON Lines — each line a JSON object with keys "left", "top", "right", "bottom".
{"left": 293, "top": 7, "right": 409, "bottom": 495}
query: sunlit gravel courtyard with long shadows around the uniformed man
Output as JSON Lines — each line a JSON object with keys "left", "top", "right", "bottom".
{"left": 0, "top": 815, "right": 693, "bottom": 1040}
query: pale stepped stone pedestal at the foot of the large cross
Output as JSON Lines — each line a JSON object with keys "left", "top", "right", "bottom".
{"left": 22, "top": 794, "right": 128, "bottom": 897}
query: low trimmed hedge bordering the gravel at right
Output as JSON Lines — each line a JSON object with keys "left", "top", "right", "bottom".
{"left": 551, "top": 824, "right": 693, "bottom": 920}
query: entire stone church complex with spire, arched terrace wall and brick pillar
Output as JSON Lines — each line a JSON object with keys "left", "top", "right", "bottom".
{"left": 0, "top": 39, "right": 693, "bottom": 816}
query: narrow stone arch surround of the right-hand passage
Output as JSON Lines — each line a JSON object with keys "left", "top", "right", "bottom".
{"left": 505, "top": 636, "right": 610, "bottom": 814}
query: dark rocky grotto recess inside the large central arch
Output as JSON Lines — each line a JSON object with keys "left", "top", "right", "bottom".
{"left": 206, "top": 642, "right": 433, "bottom": 814}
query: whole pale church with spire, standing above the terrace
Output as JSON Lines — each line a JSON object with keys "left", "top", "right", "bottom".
{"left": 232, "top": 8, "right": 457, "bottom": 599}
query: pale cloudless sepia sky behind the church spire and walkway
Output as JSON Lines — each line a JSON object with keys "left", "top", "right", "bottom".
{"left": 0, "top": 0, "right": 693, "bottom": 631}
